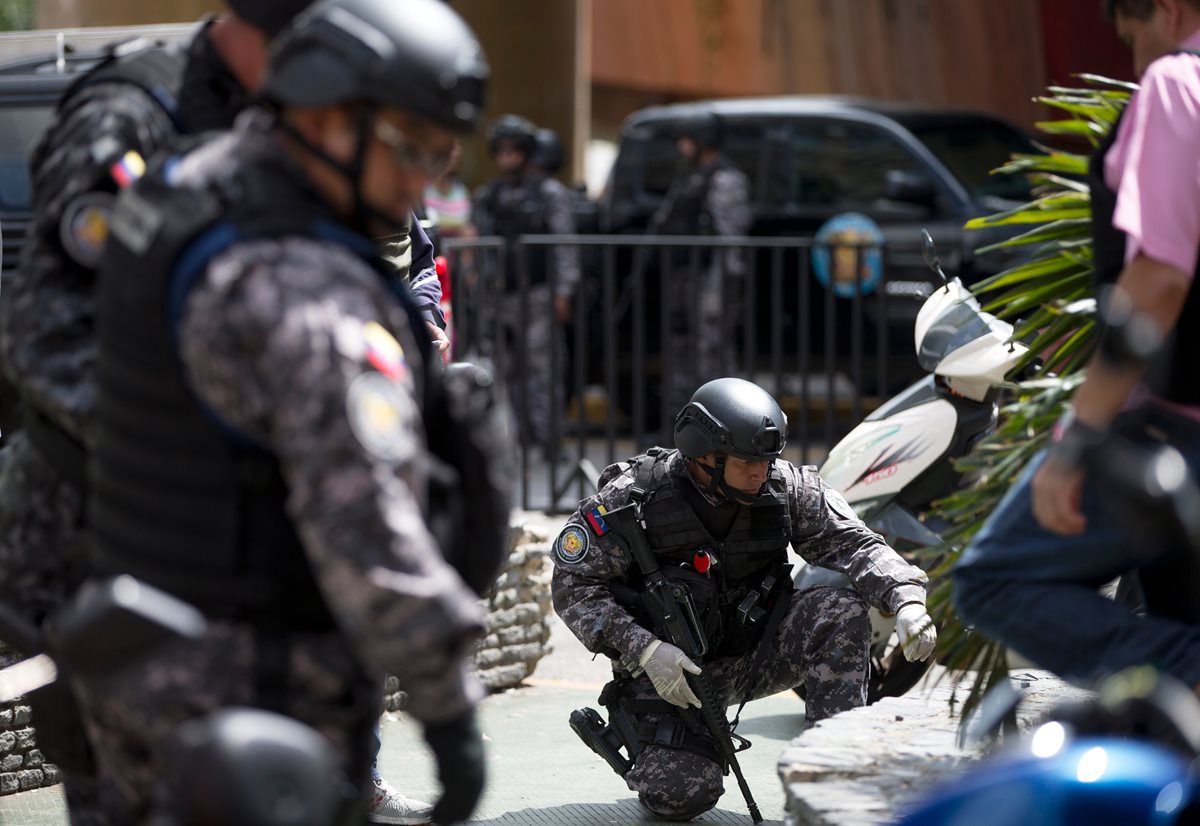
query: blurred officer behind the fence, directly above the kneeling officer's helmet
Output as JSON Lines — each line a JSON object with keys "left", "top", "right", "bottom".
{"left": 650, "top": 110, "right": 752, "bottom": 422}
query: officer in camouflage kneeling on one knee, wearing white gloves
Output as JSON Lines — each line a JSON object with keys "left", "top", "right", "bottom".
{"left": 553, "top": 378, "right": 936, "bottom": 820}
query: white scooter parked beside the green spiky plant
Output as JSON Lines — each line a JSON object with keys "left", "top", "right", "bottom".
{"left": 794, "top": 232, "right": 1027, "bottom": 702}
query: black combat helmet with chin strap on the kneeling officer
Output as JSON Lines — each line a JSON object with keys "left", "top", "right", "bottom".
{"left": 674, "top": 378, "right": 787, "bottom": 502}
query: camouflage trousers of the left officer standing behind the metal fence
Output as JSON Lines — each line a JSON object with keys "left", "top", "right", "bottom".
{"left": 498, "top": 285, "right": 566, "bottom": 451}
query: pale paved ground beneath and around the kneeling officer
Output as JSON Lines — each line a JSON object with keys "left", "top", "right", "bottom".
{"left": 0, "top": 622, "right": 804, "bottom": 826}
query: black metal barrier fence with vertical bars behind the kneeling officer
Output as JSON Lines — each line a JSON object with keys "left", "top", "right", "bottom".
{"left": 443, "top": 235, "right": 926, "bottom": 511}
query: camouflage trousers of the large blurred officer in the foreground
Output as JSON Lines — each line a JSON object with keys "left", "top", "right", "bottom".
{"left": 82, "top": 621, "right": 383, "bottom": 826}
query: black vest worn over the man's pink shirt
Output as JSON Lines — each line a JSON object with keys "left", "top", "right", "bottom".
{"left": 1088, "top": 50, "right": 1200, "bottom": 405}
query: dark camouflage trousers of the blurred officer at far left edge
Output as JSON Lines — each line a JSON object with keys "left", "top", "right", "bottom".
{"left": 0, "top": 432, "right": 108, "bottom": 826}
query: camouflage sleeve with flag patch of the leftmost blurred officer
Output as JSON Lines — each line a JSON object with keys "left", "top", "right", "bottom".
{"left": 0, "top": 83, "right": 174, "bottom": 442}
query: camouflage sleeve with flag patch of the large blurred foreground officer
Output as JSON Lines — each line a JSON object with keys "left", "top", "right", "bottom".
{"left": 179, "top": 239, "right": 482, "bottom": 722}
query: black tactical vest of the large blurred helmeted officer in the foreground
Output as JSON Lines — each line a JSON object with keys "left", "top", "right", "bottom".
{"left": 90, "top": 140, "right": 408, "bottom": 630}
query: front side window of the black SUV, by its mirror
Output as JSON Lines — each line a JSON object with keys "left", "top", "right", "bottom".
{"left": 788, "top": 120, "right": 930, "bottom": 213}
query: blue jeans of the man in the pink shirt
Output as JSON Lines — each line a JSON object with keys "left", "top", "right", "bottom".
{"left": 952, "top": 408, "right": 1200, "bottom": 686}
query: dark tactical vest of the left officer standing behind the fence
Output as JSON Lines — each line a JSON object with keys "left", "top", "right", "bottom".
{"left": 482, "top": 174, "right": 550, "bottom": 292}
